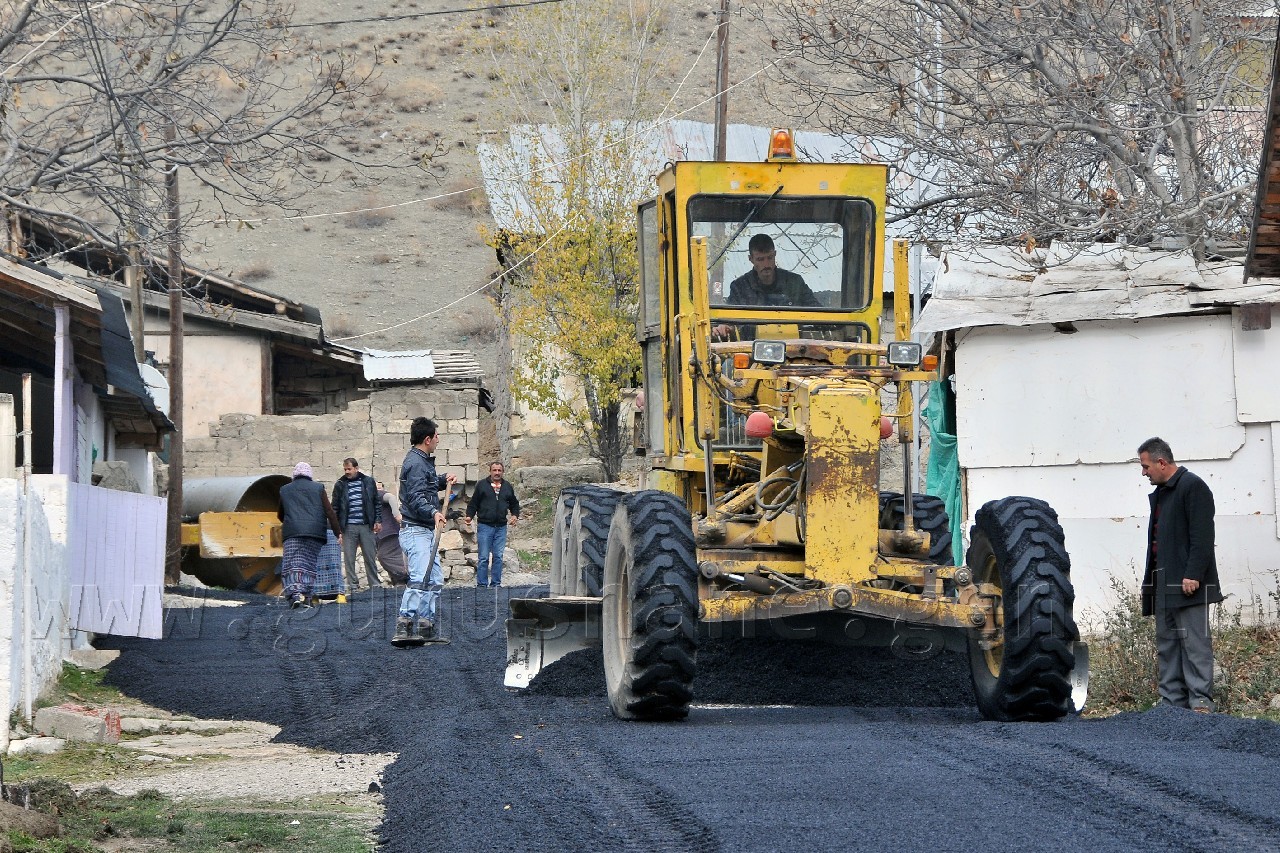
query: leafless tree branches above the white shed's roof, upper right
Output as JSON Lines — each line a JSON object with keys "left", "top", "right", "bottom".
{"left": 769, "top": 0, "right": 1276, "bottom": 255}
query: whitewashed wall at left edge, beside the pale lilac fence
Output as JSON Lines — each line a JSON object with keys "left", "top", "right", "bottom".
{"left": 0, "top": 475, "right": 70, "bottom": 740}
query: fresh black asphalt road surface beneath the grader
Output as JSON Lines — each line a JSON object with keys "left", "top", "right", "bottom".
{"left": 100, "top": 588, "right": 1280, "bottom": 853}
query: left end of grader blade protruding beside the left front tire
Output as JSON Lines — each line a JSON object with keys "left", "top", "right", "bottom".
{"left": 503, "top": 596, "right": 600, "bottom": 688}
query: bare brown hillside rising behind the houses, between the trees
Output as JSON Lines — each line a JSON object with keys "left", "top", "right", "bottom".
{"left": 186, "top": 0, "right": 777, "bottom": 374}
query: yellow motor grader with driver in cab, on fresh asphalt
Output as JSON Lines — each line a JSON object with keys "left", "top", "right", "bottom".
{"left": 506, "top": 131, "right": 1088, "bottom": 720}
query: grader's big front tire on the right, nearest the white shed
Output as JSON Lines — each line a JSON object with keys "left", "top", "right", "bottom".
{"left": 966, "top": 497, "right": 1080, "bottom": 721}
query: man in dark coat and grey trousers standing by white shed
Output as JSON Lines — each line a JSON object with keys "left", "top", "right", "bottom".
{"left": 1138, "top": 438, "right": 1222, "bottom": 713}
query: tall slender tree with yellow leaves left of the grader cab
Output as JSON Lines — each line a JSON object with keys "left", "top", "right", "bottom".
{"left": 488, "top": 0, "right": 666, "bottom": 480}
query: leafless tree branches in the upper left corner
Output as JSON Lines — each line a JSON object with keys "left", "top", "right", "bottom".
{"left": 0, "top": 0, "right": 372, "bottom": 256}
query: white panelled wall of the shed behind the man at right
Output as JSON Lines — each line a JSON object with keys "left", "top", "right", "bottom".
{"left": 952, "top": 315, "right": 1280, "bottom": 622}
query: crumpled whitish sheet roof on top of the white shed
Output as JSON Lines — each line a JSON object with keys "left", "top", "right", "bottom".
{"left": 915, "top": 245, "right": 1280, "bottom": 334}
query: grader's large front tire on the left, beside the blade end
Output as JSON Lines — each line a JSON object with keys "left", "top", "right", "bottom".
{"left": 602, "top": 491, "right": 698, "bottom": 720}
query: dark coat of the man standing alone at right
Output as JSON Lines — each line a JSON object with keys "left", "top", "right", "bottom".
{"left": 1142, "top": 467, "right": 1222, "bottom": 616}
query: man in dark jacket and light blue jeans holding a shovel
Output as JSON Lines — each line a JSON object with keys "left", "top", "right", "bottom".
{"left": 392, "top": 418, "right": 457, "bottom": 646}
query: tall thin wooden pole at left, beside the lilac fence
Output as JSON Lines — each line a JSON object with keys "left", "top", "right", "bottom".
{"left": 163, "top": 120, "right": 183, "bottom": 584}
